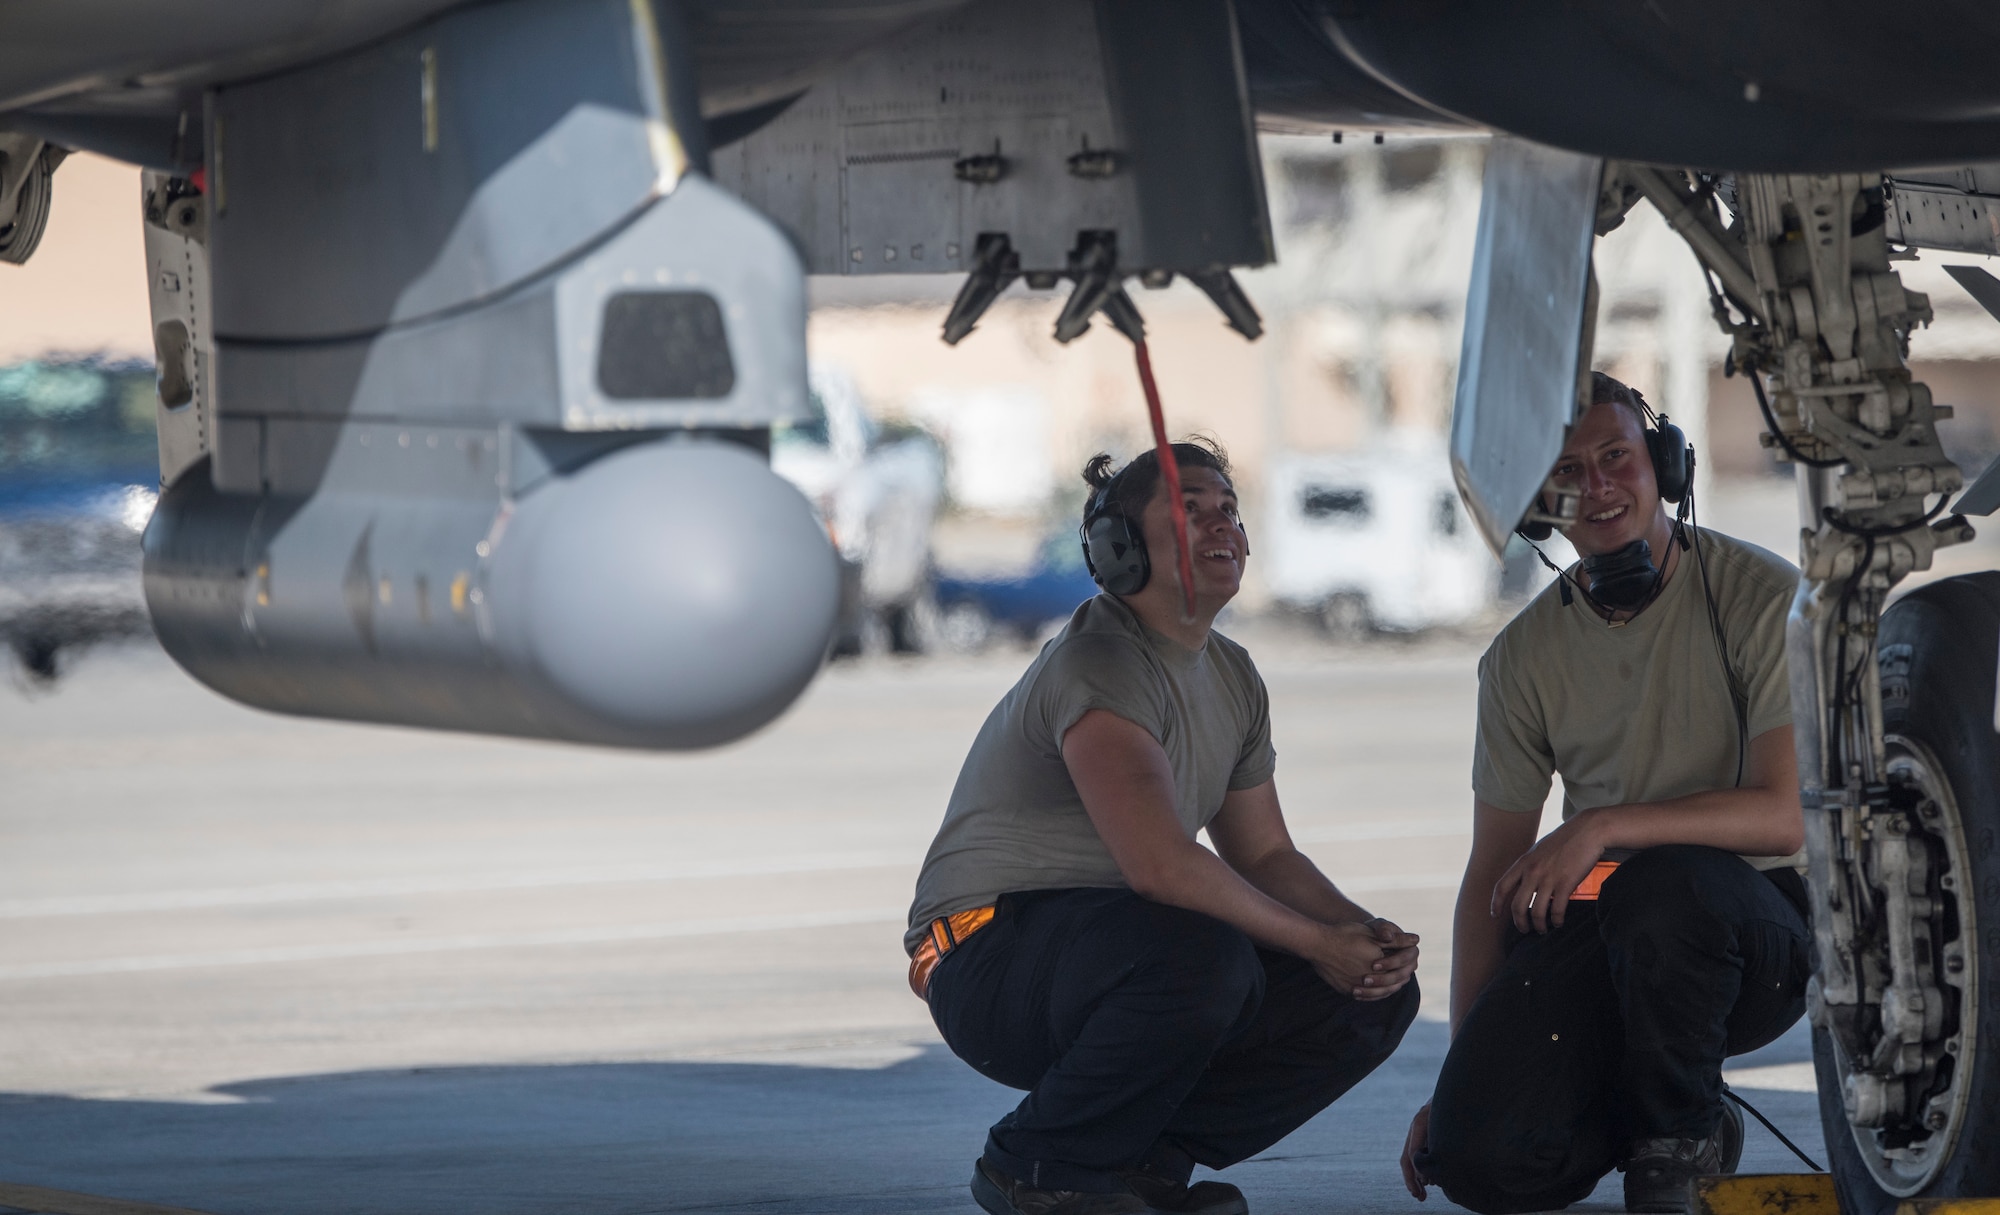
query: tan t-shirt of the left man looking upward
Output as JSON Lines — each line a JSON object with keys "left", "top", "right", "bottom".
{"left": 904, "top": 596, "right": 1278, "bottom": 951}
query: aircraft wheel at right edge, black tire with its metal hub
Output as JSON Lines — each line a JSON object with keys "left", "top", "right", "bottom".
{"left": 1812, "top": 572, "right": 2000, "bottom": 1215}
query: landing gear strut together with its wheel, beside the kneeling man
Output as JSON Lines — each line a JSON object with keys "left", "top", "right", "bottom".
{"left": 1640, "top": 166, "right": 2000, "bottom": 1215}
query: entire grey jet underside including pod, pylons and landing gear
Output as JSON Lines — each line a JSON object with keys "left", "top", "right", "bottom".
{"left": 0, "top": 0, "right": 2000, "bottom": 1213}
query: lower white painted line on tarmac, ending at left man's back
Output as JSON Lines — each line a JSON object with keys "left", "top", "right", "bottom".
{"left": 0, "top": 907, "right": 908, "bottom": 983}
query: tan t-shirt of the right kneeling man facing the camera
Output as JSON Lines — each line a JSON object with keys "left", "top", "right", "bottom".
{"left": 1472, "top": 528, "right": 1804, "bottom": 869}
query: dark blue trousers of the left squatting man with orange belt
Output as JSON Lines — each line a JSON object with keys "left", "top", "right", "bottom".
{"left": 930, "top": 889, "right": 1418, "bottom": 1193}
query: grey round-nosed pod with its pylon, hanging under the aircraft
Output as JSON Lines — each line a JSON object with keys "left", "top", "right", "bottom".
{"left": 144, "top": 0, "right": 840, "bottom": 747}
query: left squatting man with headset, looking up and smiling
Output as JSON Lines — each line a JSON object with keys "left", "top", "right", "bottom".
{"left": 904, "top": 444, "right": 1418, "bottom": 1215}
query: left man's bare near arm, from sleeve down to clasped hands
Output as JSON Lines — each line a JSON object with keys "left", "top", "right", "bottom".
{"left": 1062, "top": 709, "right": 1414, "bottom": 999}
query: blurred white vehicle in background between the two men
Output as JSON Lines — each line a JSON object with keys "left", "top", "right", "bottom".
{"left": 1252, "top": 434, "right": 1500, "bottom": 633}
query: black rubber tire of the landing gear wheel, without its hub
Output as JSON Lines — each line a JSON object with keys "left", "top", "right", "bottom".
{"left": 1812, "top": 572, "right": 2000, "bottom": 1215}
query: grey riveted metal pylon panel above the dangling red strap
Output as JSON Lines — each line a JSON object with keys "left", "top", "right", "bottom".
{"left": 714, "top": 0, "right": 1272, "bottom": 274}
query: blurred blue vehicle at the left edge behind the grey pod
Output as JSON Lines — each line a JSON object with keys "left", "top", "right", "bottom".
{"left": 0, "top": 358, "right": 160, "bottom": 679}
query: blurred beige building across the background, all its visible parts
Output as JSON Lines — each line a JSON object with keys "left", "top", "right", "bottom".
{"left": 15, "top": 136, "right": 2000, "bottom": 604}
